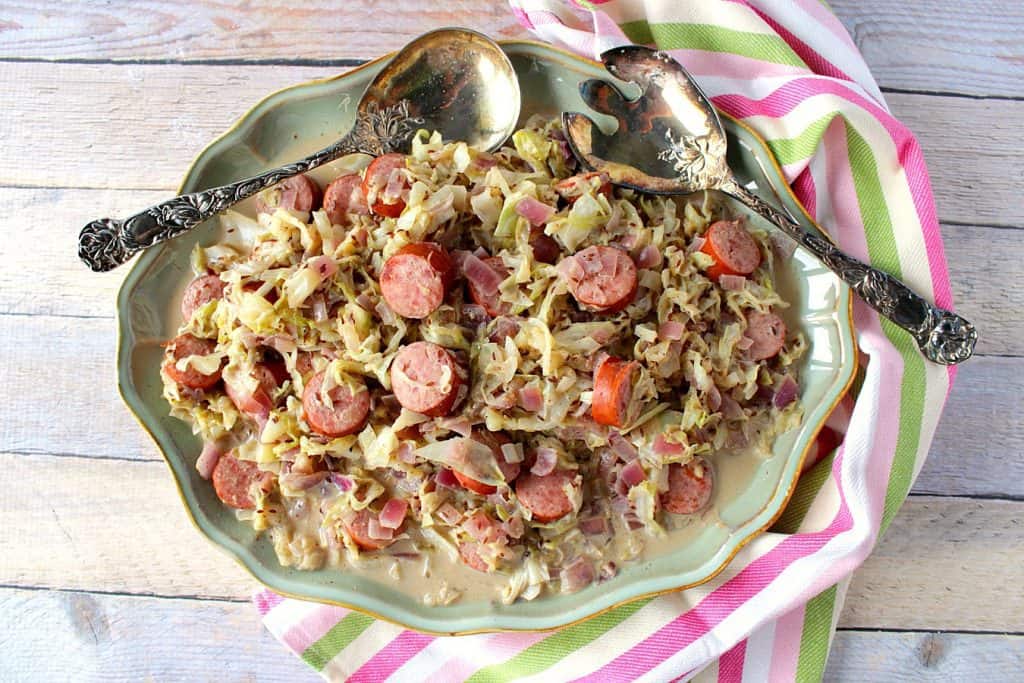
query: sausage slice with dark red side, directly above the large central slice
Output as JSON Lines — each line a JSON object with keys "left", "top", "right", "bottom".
{"left": 380, "top": 242, "right": 455, "bottom": 319}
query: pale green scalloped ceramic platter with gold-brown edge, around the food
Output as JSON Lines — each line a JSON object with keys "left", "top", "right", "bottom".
{"left": 118, "top": 41, "right": 856, "bottom": 633}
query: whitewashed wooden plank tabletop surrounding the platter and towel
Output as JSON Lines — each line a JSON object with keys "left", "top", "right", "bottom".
{"left": 0, "top": 0, "right": 1024, "bottom": 681}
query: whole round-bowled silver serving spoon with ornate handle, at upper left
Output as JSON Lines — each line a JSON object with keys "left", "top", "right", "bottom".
{"left": 78, "top": 29, "right": 520, "bottom": 271}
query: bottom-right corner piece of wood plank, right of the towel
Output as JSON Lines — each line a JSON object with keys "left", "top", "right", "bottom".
{"left": 824, "top": 631, "right": 1024, "bottom": 683}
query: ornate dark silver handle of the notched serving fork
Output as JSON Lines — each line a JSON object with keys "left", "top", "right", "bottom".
{"left": 719, "top": 178, "right": 978, "bottom": 366}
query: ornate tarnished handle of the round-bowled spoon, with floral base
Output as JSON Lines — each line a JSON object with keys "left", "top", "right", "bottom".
{"left": 78, "top": 100, "right": 419, "bottom": 272}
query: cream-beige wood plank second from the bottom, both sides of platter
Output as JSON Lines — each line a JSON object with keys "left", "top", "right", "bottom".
{"left": 0, "top": 454, "right": 1024, "bottom": 631}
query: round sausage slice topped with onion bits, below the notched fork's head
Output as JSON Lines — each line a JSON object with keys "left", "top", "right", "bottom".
{"left": 558, "top": 246, "right": 637, "bottom": 313}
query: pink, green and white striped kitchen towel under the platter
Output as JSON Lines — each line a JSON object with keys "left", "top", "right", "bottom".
{"left": 256, "top": 0, "right": 954, "bottom": 681}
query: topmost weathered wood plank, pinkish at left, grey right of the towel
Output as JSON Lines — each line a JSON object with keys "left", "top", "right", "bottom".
{"left": 0, "top": 0, "right": 1024, "bottom": 96}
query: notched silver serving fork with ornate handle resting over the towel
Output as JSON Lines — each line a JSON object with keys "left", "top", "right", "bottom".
{"left": 562, "top": 45, "right": 978, "bottom": 365}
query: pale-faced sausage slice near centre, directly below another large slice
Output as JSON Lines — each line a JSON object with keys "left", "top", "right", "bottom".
{"left": 391, "top": 341, "right": 465, "bottom": 418}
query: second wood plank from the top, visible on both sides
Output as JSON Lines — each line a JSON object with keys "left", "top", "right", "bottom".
{"left": 0, "top": 63, "right": 1024, "bottom": 226}
